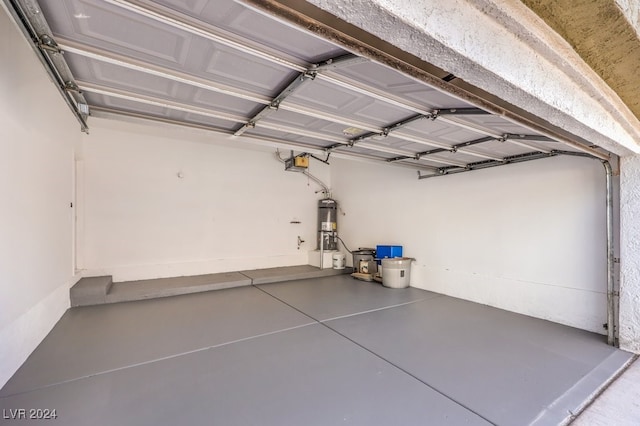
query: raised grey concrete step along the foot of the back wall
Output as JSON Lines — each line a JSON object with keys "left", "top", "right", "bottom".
{"left": 70, "top": 265, "right": 351, "bottom": 306}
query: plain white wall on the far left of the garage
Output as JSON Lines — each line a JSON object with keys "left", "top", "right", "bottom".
{"left": 0, "top": 9, "right": 80, "bottom": 387}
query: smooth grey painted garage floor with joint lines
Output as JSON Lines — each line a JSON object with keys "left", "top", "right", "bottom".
{"left": 0, "top": 276, "right": 631, "bottom": 426}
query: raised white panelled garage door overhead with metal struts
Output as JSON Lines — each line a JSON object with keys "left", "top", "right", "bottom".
{"left": 5, "top": 0, "right": 603, "bottom": 178}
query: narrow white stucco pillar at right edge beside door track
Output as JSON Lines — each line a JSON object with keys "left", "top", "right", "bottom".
{"left": 620, "top": 155, "right": 640, "bottom": 353}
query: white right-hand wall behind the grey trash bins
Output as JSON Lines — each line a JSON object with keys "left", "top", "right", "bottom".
{"left": 332, "top": 158, "right": 606, "bottom": 333}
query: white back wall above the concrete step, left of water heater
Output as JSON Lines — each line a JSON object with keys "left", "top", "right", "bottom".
{"left": 81, "top": 119, "right": 329, "bottom": 281}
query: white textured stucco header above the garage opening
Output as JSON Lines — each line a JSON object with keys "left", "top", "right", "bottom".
{"left": 309, "top": 0, "right": 640, "bottom": 155}
